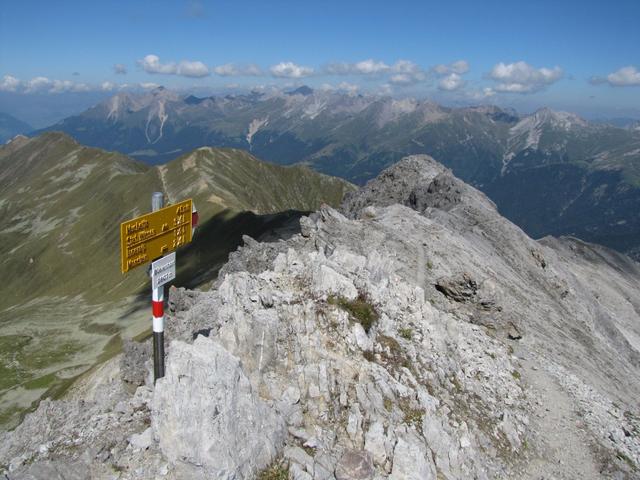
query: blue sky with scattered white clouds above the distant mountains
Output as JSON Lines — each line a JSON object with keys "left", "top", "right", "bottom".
{"left": 0, "top": 0, "right": 640, "bottom": 124}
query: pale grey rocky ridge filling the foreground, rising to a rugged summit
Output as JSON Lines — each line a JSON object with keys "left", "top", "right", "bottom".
{"left": 0, "top": 156, "right": 640, "bottom": 480}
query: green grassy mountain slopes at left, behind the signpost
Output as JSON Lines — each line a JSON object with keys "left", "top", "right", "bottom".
{"left": 0, "top": 133, "right": 354, "bottom": 425}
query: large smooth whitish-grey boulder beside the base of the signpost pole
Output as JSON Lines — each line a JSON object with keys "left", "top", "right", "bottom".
{"left": 152, "top": 337, "right": 285, "bottom": 479}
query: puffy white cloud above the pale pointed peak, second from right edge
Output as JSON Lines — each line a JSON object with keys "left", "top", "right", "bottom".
{"left": 489, "top": 61, "right": 563, "bottom": 93}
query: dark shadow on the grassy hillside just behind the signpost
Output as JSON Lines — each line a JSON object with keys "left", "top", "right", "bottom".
{"left": 121, "top": 210, "right": 309, "bottom": 318}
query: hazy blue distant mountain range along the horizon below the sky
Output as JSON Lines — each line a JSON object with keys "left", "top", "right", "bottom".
{"left": 38, "top": 87, "right": 640, "bottom": 258}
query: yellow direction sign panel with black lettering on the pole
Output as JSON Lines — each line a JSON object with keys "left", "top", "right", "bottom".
{"left": 120, "top": 199, "right": 193, "bottom": 273}
